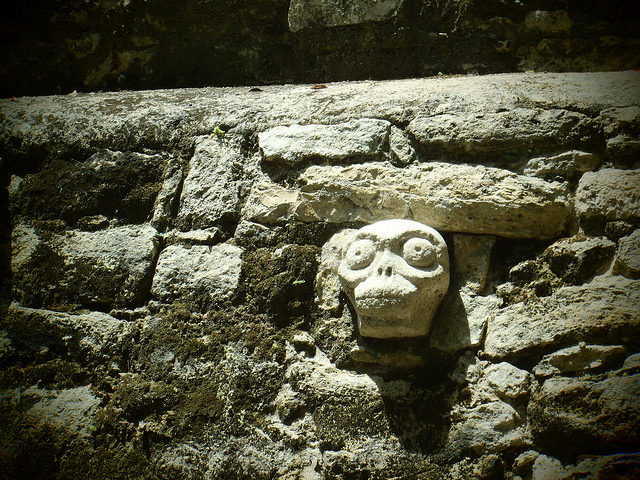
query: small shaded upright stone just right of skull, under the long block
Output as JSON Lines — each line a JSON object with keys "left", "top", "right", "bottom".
{"left": 453, "top": 235, "right": 496, "bottom": 293}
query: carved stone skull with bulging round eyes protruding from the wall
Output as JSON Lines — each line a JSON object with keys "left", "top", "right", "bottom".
{"left": 338, "top": 220, "right": 449, "bottom": 338}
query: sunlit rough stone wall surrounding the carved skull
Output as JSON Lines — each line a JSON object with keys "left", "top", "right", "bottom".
{"left": 0, "top": 72, "right": 640, "bottom": 480}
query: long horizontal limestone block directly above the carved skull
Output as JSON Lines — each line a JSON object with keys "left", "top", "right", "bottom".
{"left": 244, "top": 162, "right": 569, "bottom": 238}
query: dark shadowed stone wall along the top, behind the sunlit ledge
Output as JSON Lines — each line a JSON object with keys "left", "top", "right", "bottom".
{"left": 0, "top": 0, "right": 640, "bottom": 97}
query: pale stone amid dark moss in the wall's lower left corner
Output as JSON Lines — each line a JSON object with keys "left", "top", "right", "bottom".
{"left": 27, "top": 386, "right": 100, "bottom": 438}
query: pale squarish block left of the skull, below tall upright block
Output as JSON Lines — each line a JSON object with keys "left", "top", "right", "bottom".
{"left": 151, "top": 244, "right": 242, "bottom": 301}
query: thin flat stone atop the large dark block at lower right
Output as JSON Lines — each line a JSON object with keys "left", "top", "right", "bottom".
{"left": 533, "top": 343, "right": 626, "bottom": 378}
